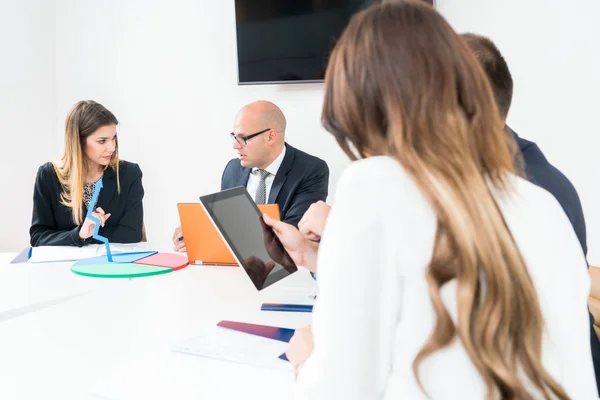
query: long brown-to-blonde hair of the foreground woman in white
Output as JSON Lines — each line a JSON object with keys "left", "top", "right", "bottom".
{"left": 322, "top": 1, "right": 568, "bottom": 399}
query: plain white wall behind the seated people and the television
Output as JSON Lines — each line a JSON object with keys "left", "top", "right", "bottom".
{"left": 0, "top": 0, "right": 600, "bottom": 264}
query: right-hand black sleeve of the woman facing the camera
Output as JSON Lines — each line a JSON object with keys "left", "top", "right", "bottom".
{"left": 98, "top": 164, "right": 144, "bottom": 243}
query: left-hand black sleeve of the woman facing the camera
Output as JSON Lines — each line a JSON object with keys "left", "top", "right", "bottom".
{"left": 29, "top": 164, "right": 87, "bottom": 247}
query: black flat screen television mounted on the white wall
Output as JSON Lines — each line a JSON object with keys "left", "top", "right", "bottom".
{"left": 235, "top": 0, "right": 433, "bottom": 84}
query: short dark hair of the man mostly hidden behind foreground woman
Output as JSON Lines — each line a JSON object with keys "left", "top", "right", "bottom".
{"left": 460, "top": 33, "right": 513, "bottom": 119}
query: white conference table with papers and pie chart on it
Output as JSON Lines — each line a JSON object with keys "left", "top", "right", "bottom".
{"left": 0, "top": 254, "right": 316, "bottom": 400}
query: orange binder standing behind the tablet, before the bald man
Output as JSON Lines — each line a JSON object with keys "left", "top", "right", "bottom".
{"left": 177, "top": 203, "right": 280, "bottom": 266}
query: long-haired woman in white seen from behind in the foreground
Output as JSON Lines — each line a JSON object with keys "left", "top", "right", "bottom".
{"left": 271, "top": 1, "right": 597, "bottom": 400}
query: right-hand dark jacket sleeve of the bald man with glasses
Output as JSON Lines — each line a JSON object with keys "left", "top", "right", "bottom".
{"left": 283, "top": 160, "right": 329, "bottom": 227}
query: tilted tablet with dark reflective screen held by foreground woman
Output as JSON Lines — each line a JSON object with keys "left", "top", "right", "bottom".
{"left": 200, "top": 187, "right": 298, "bottom": 290}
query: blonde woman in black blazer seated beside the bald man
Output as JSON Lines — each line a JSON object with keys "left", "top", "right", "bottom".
{"left": 29, "top": 100, "right": 144, "bottom": 246}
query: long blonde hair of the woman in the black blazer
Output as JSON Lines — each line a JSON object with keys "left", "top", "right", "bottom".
{"left": 53, "top": 100, "right": 121, "bottom": 225}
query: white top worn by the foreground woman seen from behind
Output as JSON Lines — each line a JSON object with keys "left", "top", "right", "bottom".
{"left": 294, "top": 157, "right": 597, "bottom": 400}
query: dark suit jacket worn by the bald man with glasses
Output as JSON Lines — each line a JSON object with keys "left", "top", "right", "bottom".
{"left": 221, "top": 143, "right": 329, "bottom": 226}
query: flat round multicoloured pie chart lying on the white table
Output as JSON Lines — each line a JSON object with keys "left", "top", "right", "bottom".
{"left": 71, "top": 251, "right": 188, "bottom": 278}
